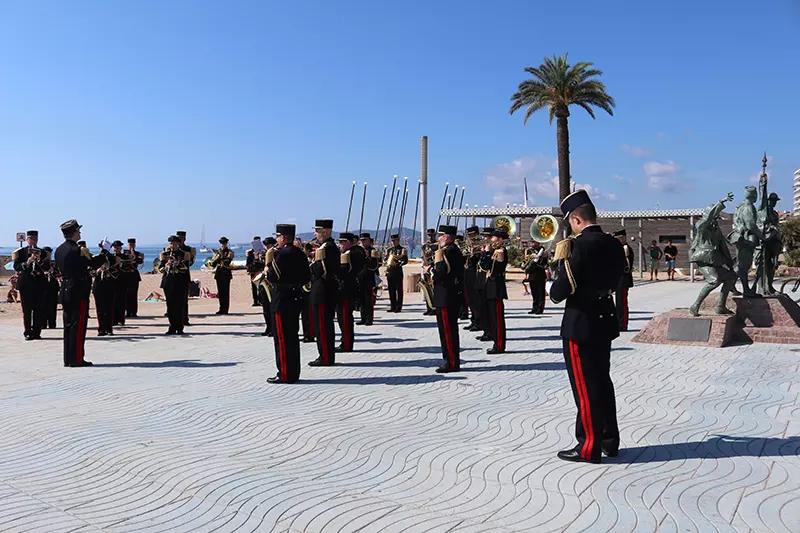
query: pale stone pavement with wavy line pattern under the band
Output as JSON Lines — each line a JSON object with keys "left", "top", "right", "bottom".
{"left": 0, "top": 282, "right": 800, "bottom": 533}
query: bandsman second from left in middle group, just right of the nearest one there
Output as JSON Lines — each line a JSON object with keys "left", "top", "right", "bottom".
{"left": 309, "top": 219, "right": 341, "bottom": 366}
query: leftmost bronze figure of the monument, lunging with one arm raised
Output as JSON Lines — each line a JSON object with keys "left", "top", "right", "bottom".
{"left": 689, "top": 192, "right": 736, "bottom": 316}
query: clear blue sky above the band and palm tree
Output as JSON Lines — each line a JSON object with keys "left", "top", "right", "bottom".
{"left": 0, "top": 0, "right": 800, "bottom": 245}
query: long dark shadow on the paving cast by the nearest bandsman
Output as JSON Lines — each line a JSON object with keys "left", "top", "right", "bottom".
{"left": 605, "top": 435, "right": 800, "bottom": 464}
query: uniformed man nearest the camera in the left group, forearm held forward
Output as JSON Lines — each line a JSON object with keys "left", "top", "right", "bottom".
{"left": 55, "top": 219, "right": 105, "bottom": 367}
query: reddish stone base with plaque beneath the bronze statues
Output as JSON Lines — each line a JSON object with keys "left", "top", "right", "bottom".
{"left": 633, "top": 294, "right": 800, "bottom": 347}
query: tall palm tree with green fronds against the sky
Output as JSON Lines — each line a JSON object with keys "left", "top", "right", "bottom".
{"left": 509, "top": 55, "right": 616, "bottom": 201}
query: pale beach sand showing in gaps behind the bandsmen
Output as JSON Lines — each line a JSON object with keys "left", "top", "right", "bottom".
{"left": 0, "top": 263, "right": 530, "bottom": 326}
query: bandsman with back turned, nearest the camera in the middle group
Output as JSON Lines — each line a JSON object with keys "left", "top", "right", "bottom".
{"left": 266, "top": 224, "right": 310, "bottom": 383}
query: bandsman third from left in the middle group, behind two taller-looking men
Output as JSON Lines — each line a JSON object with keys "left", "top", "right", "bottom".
{"left": 336, "top": 233, "right": 364, "bottom": 352}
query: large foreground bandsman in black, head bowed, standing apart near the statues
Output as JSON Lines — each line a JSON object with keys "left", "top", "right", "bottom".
{"left": 550, "top": 189, "right": 625, "bottom": 463}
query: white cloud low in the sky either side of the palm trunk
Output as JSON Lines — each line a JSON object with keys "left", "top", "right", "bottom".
{"left": 485, "top": 156, "right": 617, "bottom": 206}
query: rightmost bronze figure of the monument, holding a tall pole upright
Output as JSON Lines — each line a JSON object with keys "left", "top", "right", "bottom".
{"left": 753, "top": 153, "right": 783, "bottom": 296}
